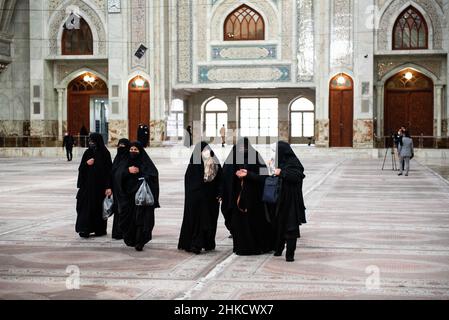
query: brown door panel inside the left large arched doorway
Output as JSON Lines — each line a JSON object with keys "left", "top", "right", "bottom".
{"left": 67, "top": 94, "right": 90, "bottom": 136}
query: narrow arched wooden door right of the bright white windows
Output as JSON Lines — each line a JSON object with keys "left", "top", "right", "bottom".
{"left": 329, "top": 75, "right": 354, "bottom": 148}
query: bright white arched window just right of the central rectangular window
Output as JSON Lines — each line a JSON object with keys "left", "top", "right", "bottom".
{"left": 290, "top": 98, "right": 315, "bottom": 138}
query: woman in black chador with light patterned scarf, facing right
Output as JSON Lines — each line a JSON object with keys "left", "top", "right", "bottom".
{"left": 178, "top": 142, "right": 222, "bottom": 254}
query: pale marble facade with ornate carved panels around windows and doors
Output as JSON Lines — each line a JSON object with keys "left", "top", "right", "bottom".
{"left": 0, "top": 0, "right": 449, "bottom": 146}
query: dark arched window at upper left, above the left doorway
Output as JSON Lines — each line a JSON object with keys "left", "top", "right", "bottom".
{"left": 62, "top": 18, "right": 94, "bottom": 55}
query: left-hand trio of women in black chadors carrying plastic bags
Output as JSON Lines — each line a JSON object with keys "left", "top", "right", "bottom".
{"left": 76, "top": 133, "right": 159, "bottom": 251}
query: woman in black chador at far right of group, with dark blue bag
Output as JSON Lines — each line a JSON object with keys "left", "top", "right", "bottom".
{"left": 271, "top": 141, "right": 307, "bottom": 261}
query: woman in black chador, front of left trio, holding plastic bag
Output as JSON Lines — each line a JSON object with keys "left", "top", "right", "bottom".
{"left": 118, "top": 142, "right": 160, "bottom": 251}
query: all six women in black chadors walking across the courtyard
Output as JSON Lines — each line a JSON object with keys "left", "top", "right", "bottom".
{"left": 76, "top": 133, "right": 306, "bottom": 261}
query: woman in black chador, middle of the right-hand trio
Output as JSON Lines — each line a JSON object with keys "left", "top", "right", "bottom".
{"left": 221, "top": 138, "right": 273, "bottom": 255}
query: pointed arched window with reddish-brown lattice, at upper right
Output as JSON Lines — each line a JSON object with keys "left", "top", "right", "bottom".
{"left": 393, "top": 6, "right": 429, "bottom": 50}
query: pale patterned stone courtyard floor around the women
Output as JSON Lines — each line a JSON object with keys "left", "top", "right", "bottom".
{"left": 0, "top": 148, "right": 449, "bottom": 299}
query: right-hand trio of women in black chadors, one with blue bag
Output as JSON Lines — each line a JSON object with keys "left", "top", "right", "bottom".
{"left": 178, "top": 138, "right": 306, "bottom": 261}
